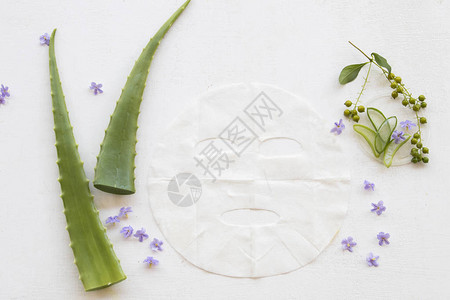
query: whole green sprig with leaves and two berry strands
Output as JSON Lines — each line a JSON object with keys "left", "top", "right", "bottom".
{"left": 339, "top": 41, "right": 429, "bottom": 163}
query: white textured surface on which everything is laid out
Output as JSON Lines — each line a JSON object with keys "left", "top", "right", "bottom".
{"left": 0, "top": 0, "right": 450, "bottom": 299}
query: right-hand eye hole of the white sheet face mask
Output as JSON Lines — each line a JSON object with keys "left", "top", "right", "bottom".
{"left": 259, "top": 137, "right": 303, "bottom": 156}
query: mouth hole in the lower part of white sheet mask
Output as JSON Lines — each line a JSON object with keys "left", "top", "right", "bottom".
{"left": 221, "top": 208, "right": 280, "bottom": 226}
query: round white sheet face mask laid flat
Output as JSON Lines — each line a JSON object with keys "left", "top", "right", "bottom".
{"left": 148, "top": 84, "right": 350, "bottom": 277}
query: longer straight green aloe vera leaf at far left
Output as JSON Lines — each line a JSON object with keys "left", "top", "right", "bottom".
{"left": 49, "top": 29, "right": 127, "bottom": 291}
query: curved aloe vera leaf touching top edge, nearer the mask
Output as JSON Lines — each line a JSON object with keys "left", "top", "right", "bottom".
{"left": 94, "top": 0, "right": 190, "bottom": 195}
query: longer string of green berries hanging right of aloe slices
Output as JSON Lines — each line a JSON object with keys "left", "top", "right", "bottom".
{"left": 387, "top": 73, "right": 429, "bottom": 163}
